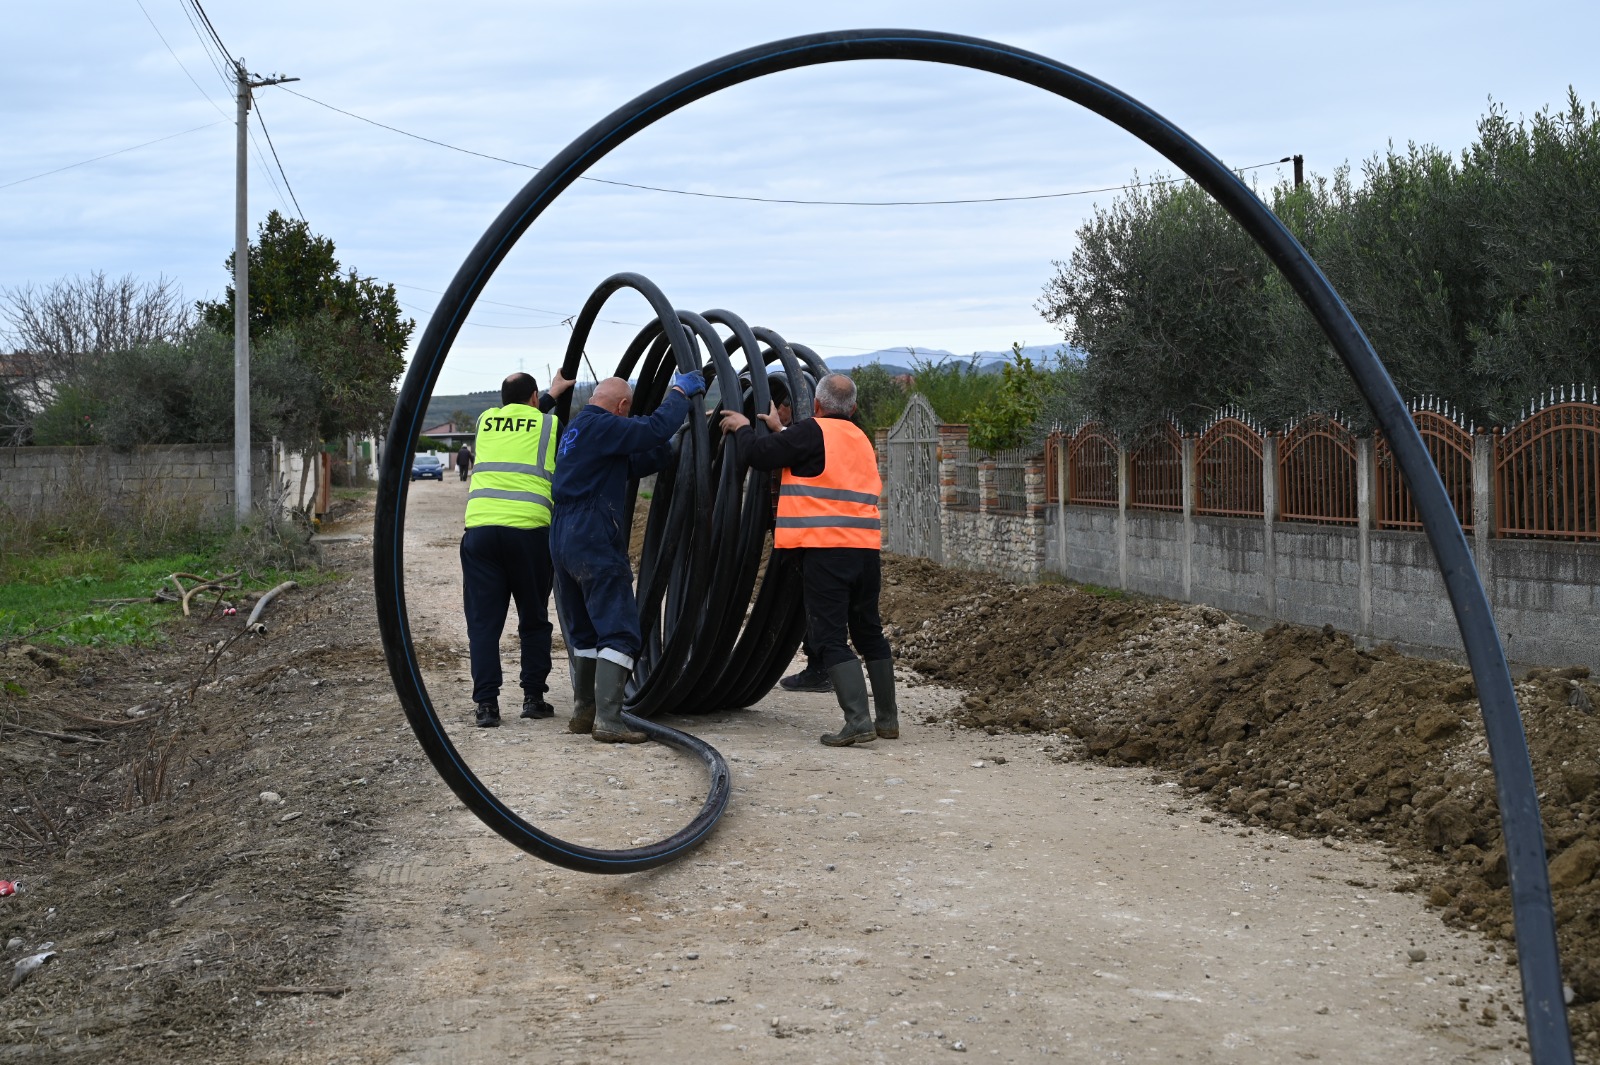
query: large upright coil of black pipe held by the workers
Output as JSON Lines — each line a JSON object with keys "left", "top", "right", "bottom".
{"left": 557, "top": 273, "right": 827, "bottom": 718}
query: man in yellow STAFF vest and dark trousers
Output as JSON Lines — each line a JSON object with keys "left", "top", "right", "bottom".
{"left": 461, "top": 373, "right": 573, "bottom": 729}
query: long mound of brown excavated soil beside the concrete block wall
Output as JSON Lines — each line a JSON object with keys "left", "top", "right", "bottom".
{"left": 883, "top": 556, "right": 1600, "bottom": 1046}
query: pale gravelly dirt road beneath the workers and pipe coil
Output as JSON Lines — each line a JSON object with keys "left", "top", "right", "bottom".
{"left": 281, "top": 481, "right": 1526, "bottom": 1065}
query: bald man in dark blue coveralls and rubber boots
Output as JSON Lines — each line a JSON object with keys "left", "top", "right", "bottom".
{"left": 550, "top": 373, "right": 706, "bottom": 744}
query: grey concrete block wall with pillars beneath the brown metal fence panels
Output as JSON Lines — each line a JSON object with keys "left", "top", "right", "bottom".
{"left": 876, "top": 409, "right": 1600, "bottom": 672}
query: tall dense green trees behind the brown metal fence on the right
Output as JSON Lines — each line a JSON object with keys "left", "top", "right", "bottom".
{"left": 1040, "top": 91, "right": 1600, "bottom": 435}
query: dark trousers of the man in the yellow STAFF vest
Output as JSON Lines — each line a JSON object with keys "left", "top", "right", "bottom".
{"left": 461, "top": 525, "right": 554, "bottom": 702}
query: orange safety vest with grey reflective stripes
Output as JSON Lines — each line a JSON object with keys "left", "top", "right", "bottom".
{"left": 773, "top": 417, "right": 883, "bottom": 550}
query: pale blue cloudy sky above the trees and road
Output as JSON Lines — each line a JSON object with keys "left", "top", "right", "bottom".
{"left": 0, "top": 0, "right": 1600, "bottom": 392}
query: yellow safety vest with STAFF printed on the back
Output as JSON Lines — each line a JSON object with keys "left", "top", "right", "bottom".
{"left": 467, "top": 403, "right": 562, "bottom": 529}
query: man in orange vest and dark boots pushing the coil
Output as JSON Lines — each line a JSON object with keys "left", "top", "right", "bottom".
{"left": 722, "top": 374, "right": 899, "bottom": 747}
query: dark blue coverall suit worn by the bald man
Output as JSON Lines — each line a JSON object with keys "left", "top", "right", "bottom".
{"left": 550, "top": 390, "right": 690, "bottom": 668}
